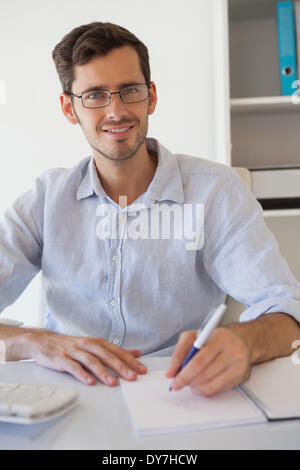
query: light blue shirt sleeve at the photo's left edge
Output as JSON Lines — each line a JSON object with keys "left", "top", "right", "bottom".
{"left": 0, "top": 173, "right": 45, "bottom": 312}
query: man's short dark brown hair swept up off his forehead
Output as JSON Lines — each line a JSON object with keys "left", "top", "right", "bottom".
{"left": 52, "top": 21, "right": 150, "bottom": 93}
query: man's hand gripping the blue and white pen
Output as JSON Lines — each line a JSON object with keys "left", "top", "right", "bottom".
{"left": 166, "top": 327, "right": 251, "bottom": 396}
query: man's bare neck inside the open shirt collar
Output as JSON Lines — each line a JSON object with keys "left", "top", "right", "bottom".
{"left": 94, "top": 142, "right": 157, "bottom": 207}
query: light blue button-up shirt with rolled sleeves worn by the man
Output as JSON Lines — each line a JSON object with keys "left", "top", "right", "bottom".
{"left": 0, "top": 139, "right": 300, "bottom": 354}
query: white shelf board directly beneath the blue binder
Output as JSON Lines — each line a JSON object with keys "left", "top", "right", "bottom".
{"left": 230, "top": 95, "right": 300, "bottom": 114}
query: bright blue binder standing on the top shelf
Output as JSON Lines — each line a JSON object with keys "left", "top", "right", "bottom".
{"left": 277, "top": 1, "right": 297, "bottom": 95}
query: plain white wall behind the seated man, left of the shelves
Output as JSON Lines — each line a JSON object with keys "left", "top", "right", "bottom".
{"left": 0, "top": 0, "right": 223, "bottom": 324}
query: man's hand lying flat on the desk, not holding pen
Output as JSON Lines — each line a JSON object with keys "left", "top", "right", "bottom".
{"left": 18, "top": 330, "right": 147, "bottom": 386}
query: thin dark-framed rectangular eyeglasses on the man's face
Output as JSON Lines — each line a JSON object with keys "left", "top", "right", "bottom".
{"left": 66, "top": 83, "right": 151, "bottom": 108}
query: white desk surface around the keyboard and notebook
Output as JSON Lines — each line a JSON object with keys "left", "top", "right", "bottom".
{"left": 0, "top": 357, "right": 300, "bottom": 450}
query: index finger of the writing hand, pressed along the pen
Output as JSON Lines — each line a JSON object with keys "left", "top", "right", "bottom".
{"left": 171, "top": 343, "right": 221, "bottom": 390}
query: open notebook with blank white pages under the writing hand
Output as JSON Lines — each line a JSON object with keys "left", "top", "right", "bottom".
{"left": 121, "top": 357, "right": 300, "bottom": 436}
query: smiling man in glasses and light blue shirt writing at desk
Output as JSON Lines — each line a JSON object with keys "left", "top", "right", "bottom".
{"left": 0, "top": 22, "right": 300, "bottom": 396}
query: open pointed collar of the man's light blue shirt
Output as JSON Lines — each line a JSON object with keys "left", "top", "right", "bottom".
{"left": 76, "top": 138, "right": 184, "bottom": 206}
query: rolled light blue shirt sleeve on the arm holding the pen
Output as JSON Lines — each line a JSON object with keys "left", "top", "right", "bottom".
{"left": 203, "top": 174, "right": 300, "bottom": 322}
